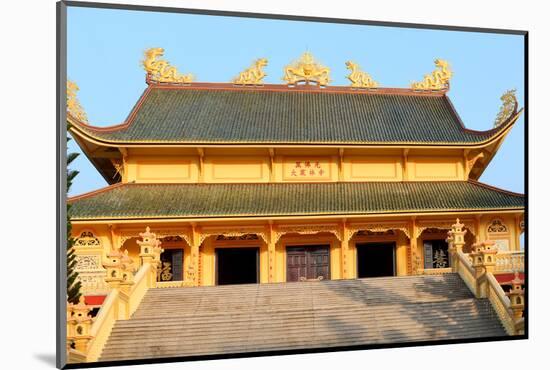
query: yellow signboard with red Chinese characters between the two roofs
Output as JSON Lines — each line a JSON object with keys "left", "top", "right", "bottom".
{"left": 283, "top": 157, "right": 332, "bottom": 181}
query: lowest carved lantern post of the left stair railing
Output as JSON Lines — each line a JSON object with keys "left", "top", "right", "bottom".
{"left": 67, "top": 296, "right": 92, "bottom": 354}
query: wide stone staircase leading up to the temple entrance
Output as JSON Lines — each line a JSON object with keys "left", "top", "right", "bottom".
{"left": 100, "top": 274, "right": 506, "bottom": 361}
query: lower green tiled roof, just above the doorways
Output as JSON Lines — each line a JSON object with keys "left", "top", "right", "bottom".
{"left": 70, "top": 181, "right": 524, "bottom": 219}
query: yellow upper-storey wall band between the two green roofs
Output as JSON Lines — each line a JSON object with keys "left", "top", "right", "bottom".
{"left": 123, "top": 149, "right": 468, "bottom": 183}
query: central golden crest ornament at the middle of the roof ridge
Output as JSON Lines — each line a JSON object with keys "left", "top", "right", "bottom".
{"left": 283, "top": 51, "right": 330, "bottom": 86}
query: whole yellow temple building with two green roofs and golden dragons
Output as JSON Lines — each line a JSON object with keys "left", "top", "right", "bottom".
{"left": 64, "top": 48, "right": 525, "bottom": 362}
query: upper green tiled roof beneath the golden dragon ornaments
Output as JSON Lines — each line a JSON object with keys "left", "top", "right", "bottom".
{"left": 80, "top": 88, "right": 504, "bottom": 144}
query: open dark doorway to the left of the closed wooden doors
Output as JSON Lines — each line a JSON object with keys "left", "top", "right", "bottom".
{"left": 216, "top": 247, "right": 259, "bottom": 285}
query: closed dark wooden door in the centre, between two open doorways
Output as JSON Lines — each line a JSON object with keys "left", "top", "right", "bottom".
{"left": 286, "top": 245, "right": 330, "bottom": 281}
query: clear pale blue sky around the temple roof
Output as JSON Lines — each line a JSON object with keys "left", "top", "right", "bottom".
{"left": 67, "top": 7, "right": 525, "bottom": 195}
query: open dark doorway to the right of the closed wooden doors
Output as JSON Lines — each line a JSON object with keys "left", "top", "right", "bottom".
{"left": 356, "top": 243, "right": 395, "bottom": 278}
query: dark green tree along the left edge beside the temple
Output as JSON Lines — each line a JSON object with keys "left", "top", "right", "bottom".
{"left": 67, "top": 130, "right": 82, "bottom": 304}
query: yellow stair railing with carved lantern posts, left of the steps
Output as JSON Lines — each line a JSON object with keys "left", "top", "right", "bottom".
{"left": 67, "top": 228, "right": 162, "bottom": 363}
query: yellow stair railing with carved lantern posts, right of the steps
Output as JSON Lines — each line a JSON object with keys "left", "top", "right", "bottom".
{"left": 447, "top": 220, "right": 525, "bottom": 335}
